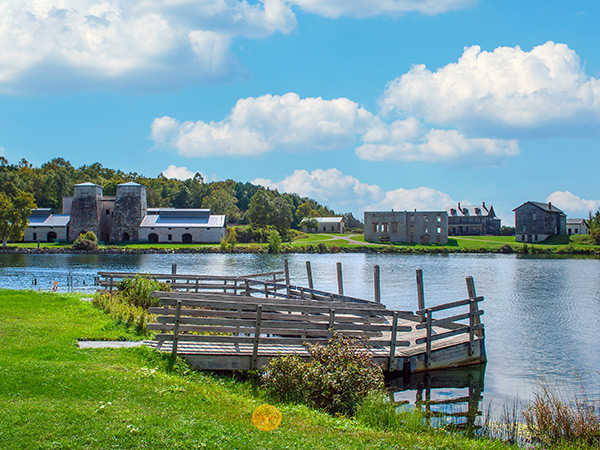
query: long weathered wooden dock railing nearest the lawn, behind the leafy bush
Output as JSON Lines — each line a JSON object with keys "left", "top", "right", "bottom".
{"left": 148, "top": 292, "right": 413, "bottom": 368}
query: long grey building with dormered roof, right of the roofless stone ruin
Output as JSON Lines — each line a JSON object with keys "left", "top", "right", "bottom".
{"left": 446, "top": 202, "right": 502, "bottom": 236}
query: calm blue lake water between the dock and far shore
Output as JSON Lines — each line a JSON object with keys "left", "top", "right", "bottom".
{"left": 0, "top": 254, "right": 600, "bottom": 414}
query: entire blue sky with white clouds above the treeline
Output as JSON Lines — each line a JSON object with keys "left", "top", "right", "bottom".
{"left": 0, "top": 0, "right": 600, "bottom": 225}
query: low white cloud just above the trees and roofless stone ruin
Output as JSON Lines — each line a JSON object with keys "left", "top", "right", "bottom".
{"left": 252, "top": 168, "right": 456, "bottom": 214}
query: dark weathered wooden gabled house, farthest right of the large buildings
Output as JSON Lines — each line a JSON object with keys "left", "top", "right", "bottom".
{"left": 513, "top": 202, "right": 567, "bottom": 242}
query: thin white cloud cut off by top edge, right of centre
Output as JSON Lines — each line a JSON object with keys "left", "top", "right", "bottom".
{"left": 290, "top": 0, "right": 477, "bottom": 18}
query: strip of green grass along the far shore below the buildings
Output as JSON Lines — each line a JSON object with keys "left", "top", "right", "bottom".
{"left": 7, "top": 233, "right": 600, "bottom": 256}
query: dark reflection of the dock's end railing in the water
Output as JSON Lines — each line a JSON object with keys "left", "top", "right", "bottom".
{"left": 386, "top": 364, "right": 486, "bottom": 430}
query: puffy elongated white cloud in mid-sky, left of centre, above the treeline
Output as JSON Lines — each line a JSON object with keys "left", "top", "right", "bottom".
{"left": 151, "top": 93, "right": 373, "bottom": 156}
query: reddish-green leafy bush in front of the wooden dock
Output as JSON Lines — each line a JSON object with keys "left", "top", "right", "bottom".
{"left": 262, "top": 334, "right": 383, "bottom": 414}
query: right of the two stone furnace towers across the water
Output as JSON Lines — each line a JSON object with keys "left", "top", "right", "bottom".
{"left": 111, "top": 182, "right": 148, "bottom": 242}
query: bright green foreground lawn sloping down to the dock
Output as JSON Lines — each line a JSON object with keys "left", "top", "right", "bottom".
{"left": 0, "top": 290, "right": 514, "bottom": 450}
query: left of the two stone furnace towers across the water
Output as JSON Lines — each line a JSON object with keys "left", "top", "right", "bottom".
{"left": 68, "top": 183, "right": 102, "bottom": 241}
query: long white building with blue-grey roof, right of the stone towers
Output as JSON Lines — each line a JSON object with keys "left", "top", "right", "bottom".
{"left": 138, "top": 208, "right": 226, "bottom": 244}
